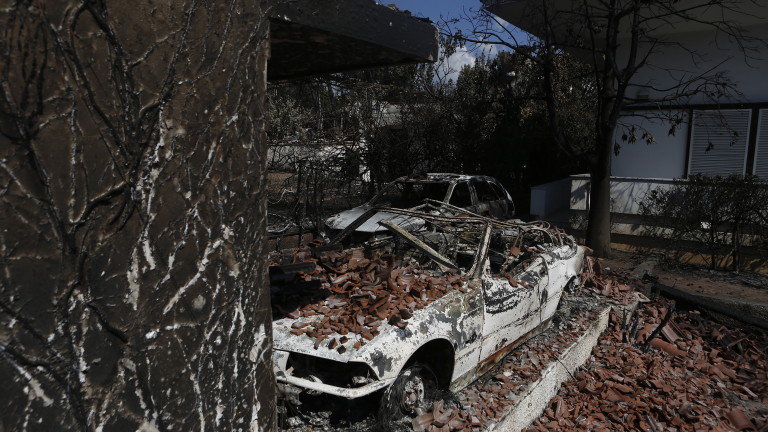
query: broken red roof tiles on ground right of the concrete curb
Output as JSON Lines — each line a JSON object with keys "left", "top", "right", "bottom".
{"left": 528, "top": 262, "right": 768, "bottom": 431}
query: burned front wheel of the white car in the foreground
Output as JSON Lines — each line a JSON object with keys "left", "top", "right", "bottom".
{"left": 377, "top": 363, "right": 439, "bottom": 432}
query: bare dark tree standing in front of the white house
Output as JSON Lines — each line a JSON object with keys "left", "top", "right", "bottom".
{"left": 446, "top": 0, "right": 766, "bottom": 256}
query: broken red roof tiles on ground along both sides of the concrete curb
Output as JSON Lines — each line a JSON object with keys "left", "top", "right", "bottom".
{"left": 404, "top": 259, "right": 768, "bottom": 432}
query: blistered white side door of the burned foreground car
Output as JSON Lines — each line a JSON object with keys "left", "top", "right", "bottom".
{"left": 480, "top": 256, "right": 549, "bottom": 362}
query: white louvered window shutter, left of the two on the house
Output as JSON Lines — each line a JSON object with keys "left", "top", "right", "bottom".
{"left": 688, "top": 110, "right": 751, "bottom": 176}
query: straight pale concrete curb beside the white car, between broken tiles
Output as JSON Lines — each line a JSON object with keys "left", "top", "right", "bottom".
{"left": 488, "top": 306, "right": 611, "bottom": 432}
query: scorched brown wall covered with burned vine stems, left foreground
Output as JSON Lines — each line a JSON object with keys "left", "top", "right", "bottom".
{"left": 0, "top": 0, "right": 275, "bottom": 432}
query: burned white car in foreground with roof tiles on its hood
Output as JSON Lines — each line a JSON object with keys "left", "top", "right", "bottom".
{"left": 270, "top": 202, "right": 584, "bottom": 428}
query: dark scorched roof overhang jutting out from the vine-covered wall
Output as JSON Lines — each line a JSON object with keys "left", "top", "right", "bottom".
{"left": 267, "top": 0, "right": 438, "bottom": 81}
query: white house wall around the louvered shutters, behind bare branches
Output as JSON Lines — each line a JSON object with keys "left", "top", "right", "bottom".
{"left": 612, "top": 21, "right": 768, "bottom": 179}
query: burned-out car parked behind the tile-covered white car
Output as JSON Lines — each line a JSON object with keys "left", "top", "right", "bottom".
{"left": 325, "top": 173, "right": 515, "bottom": 239}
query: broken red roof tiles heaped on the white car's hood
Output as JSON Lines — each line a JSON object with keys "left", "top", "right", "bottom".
{"left": 272, "top": 249, "right": 470, "bottom": 352}
